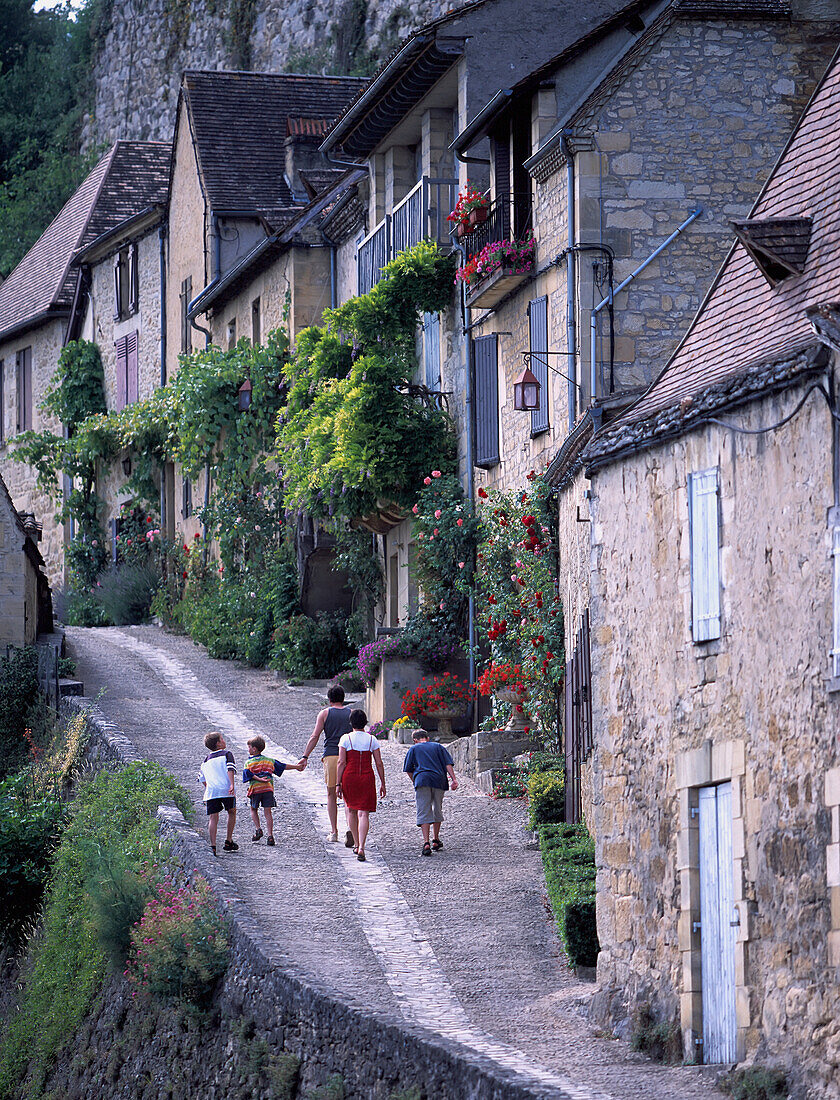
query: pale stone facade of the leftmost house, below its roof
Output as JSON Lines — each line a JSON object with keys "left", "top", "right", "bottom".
{"left": 0, "top": 320, "right": 65, "bottom": 587}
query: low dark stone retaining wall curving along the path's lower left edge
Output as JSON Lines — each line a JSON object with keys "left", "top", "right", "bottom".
{"left": 55, "top": 700, "right": 556, "bottom": 1100}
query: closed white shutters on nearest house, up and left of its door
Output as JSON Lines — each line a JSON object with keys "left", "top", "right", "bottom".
{"left": 688, "top": 466, "right": 720, "bottom": 641}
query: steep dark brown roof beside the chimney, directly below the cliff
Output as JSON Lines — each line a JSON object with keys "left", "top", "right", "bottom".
{"left": 181, "top": 70, "right": 366, "bottom": 229}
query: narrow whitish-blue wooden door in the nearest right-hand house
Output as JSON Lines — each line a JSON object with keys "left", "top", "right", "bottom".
{"left": 699, "top": 783, "right": 738, "bottom": 1064}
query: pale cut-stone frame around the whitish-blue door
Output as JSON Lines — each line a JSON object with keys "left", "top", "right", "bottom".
{"left": 675, "top": 740, "right": 747, "bottom": 1063}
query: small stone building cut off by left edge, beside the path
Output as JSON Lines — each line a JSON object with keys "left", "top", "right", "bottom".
{"left": 0, "top": 477, "right": 53, "bottom": 651}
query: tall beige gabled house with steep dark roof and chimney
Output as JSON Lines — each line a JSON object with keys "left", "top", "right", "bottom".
{"left": 163, "top": 72, "right": 364, "bottom": 538}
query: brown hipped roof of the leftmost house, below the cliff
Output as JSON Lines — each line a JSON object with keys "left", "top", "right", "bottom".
{"left": 0, "top": 141, "right": 172, "bottom": 339}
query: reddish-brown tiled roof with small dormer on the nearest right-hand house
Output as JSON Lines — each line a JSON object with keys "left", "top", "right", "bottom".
{"left": 585, "top": 49, "right": 840, "bottom": 469}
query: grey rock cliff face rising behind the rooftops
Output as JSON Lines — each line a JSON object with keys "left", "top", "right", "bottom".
{"left": 82, "top": 0, "right": 464, "bottom": 149}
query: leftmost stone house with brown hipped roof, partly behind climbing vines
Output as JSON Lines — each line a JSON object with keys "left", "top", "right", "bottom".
{"left": 0, "top": 142, "right": 168, "bottom": 585}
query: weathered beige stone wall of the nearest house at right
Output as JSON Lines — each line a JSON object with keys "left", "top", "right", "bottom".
{"left": 592, "top": 376, "right": 840, "bottom": 1100}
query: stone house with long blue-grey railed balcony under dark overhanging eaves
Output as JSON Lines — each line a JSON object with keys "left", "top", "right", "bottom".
{"left": 321, "top": 0, "right": 646, "bottom": 628}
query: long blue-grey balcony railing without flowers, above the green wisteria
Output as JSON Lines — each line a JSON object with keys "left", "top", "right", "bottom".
{"left": 356, "top": 176, "right": 458, "bottom": 294}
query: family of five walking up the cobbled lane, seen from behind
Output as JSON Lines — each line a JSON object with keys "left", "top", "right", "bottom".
{"left": 199, "top": 688, "right": 458, "bottom": 864}
